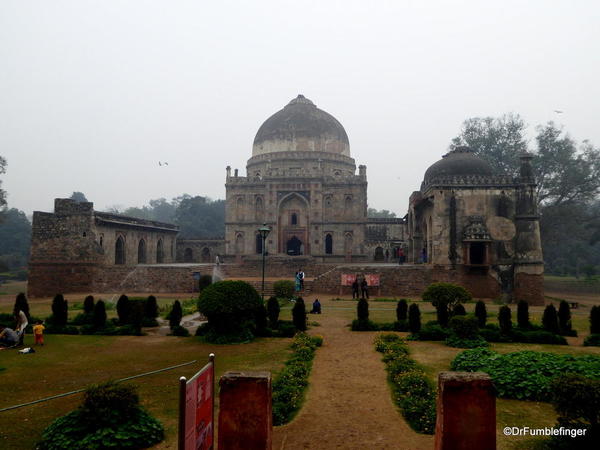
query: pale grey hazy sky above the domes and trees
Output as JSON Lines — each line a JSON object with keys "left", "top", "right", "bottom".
{"left": 0, "top": 0, "right": 600, "bottom": 215}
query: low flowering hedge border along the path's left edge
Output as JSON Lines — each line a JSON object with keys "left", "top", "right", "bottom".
{"left": 272, "top": 333, "right": 323, "bottom": 426}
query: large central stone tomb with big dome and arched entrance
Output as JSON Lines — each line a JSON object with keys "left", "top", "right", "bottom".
{"left": 225, "top": 95, "right": 384, "bottom": 262}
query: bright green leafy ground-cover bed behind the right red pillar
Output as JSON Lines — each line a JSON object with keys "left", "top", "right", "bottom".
{"left": 451, "top": 348, "right": 600, "bottom": 401}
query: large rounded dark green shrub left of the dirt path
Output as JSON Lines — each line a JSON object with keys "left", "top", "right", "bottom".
{"left": 198, "top": 280, "right": 263, "bottom": 343}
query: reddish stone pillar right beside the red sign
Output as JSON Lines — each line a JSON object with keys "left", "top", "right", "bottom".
{"left": 218, "top": 372, "right": 273, "bottom": 450}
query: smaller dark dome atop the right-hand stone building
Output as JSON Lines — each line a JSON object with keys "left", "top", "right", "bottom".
{"left": 424, "top": 147, "right": 495, "bottom": 183}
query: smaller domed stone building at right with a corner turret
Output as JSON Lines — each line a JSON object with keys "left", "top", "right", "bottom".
{"left": 407, "top": 147, "right": 544, "bottom": 304}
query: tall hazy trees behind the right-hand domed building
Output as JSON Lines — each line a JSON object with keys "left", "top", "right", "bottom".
{"left": 450, "top": 114, "right": 600, "bottom": 276}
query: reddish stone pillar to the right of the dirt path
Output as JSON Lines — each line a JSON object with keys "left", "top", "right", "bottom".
{"left": 435, "top": 372, "right": 496, "bottom": 450}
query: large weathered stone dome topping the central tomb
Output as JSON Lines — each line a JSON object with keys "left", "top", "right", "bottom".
{"left": 252, "top": 95, "right": 350, "bottom": 156}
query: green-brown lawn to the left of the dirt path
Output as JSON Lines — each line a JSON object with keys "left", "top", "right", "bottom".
{"left": 0, "top": 335, "right": 291, "bottom": 448}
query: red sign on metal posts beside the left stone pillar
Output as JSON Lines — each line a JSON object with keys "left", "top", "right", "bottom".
{"left": 179, "top": 353, "right": 215, "bottom": 450}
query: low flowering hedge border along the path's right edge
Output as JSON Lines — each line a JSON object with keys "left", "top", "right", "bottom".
{"left": 374, "top": 333, "right": 436, "bottom": 434}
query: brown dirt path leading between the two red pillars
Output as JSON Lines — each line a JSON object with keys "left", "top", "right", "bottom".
{"left": 273, "top": 301, "right": 433, "bottom": 450}
